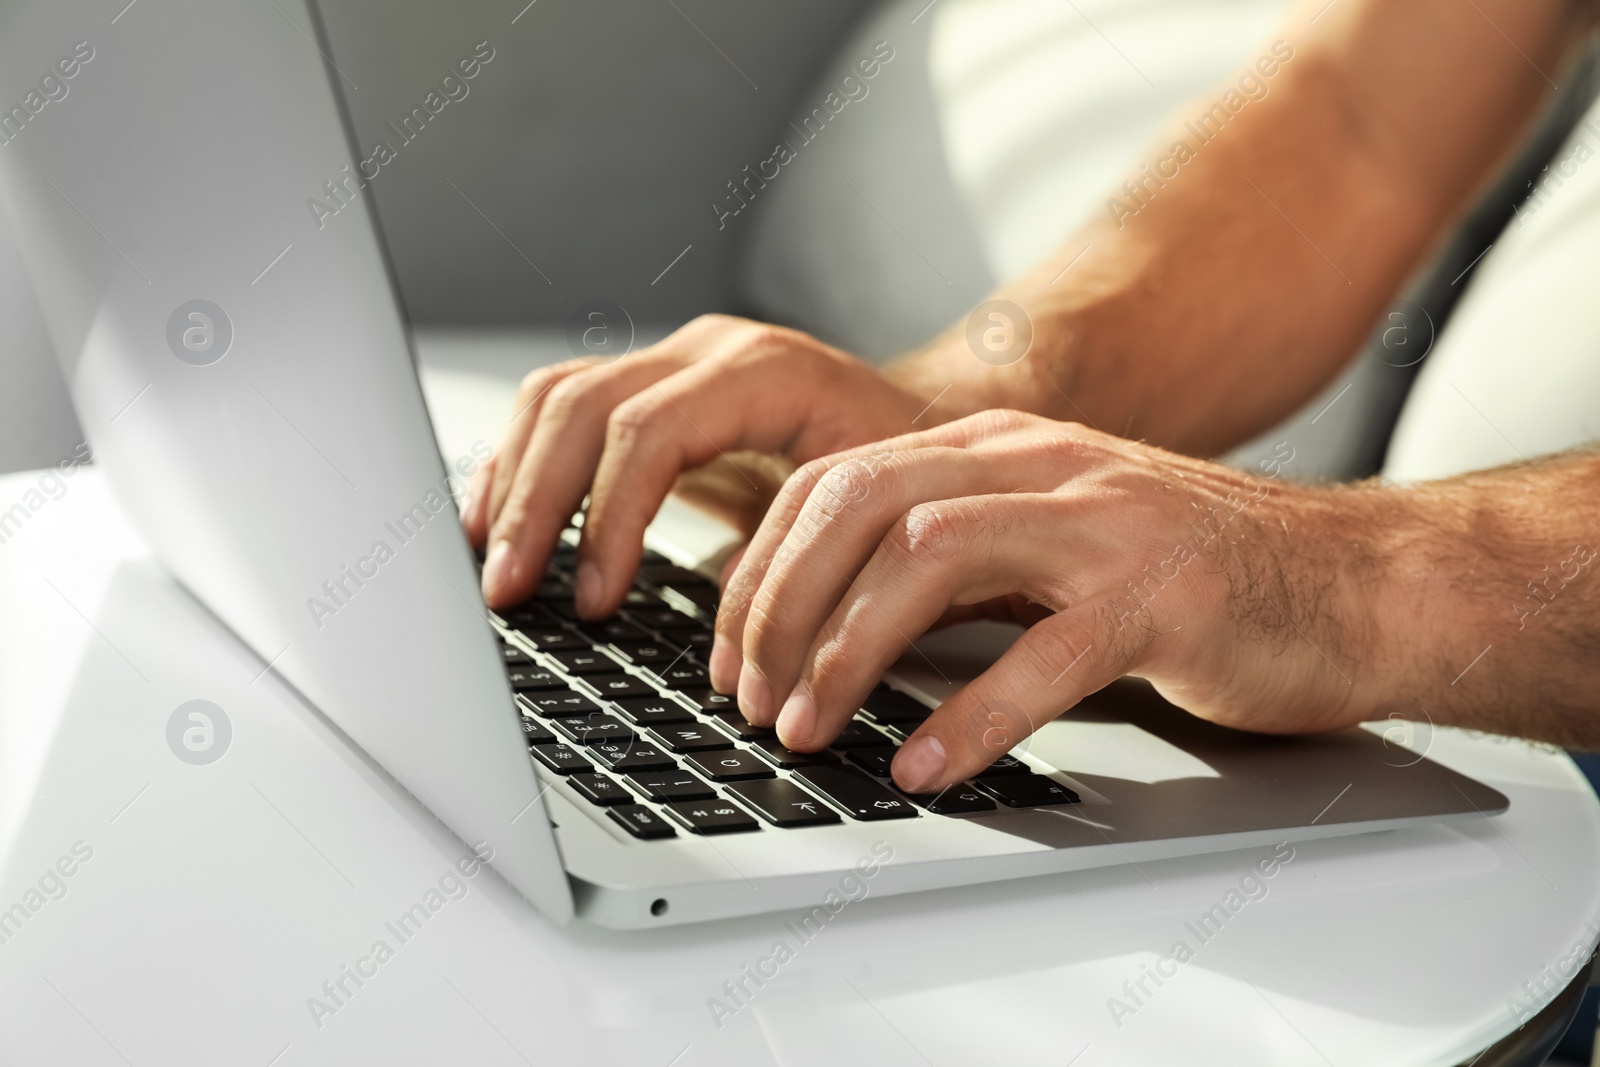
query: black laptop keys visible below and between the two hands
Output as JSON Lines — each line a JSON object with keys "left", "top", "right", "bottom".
{"left": 494, "top": 542, "right": 1078, "bottom": 840}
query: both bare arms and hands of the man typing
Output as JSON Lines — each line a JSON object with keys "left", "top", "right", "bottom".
{"left": 464, "top": 0, "right": 1600, "bottom": 790}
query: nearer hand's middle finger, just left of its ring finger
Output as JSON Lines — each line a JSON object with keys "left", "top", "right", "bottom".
{"left": 742, "top": 446, "right": 1056, "bottom": 728}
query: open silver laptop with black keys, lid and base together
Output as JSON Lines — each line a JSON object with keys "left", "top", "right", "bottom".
{"left": 0, "top": 0, "right": 1507, "bottom": 928}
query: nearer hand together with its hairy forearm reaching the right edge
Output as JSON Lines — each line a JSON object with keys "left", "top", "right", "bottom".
{"left": 718, "top": 410, "right": 1600, "bottom": 792}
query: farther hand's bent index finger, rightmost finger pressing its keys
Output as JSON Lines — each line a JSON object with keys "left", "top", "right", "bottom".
{"left": 578, "top": 347, "right": 840, "bottom": 614}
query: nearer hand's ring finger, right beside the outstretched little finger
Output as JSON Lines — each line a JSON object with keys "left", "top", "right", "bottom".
{"left": 778, "top": 493, "right": 1080, "bottom": 752}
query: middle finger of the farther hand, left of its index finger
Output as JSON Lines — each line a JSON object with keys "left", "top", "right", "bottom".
{"left": 483, "top": 354, "right": 683, "bottom": 606}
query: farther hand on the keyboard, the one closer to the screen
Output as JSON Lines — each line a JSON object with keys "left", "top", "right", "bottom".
{"left": 462, "top": 315, "right": 939, "bottom": 607}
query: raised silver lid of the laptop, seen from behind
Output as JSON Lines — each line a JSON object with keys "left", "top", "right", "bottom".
{"left": 0, "top": 0, "right": 573, "bottom": 921}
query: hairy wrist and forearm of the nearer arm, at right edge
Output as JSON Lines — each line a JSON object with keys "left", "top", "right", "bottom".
{"left": 1350, "top": 453, "right": 1600, "bottom": 749}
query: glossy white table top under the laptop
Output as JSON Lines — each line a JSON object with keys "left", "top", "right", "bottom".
{"left": 0, "top": 329, "right": 1600, "bottom": 1067}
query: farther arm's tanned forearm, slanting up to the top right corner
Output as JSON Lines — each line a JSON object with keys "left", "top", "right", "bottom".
{"left": 891, "top": 0, "right": 1587, "bottom": 453}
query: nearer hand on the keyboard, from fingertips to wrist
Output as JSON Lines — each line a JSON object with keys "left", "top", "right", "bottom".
{"left": 712, "top": 411, "right": 1401, "bottom": 792}
